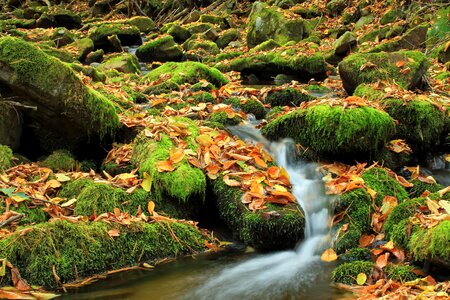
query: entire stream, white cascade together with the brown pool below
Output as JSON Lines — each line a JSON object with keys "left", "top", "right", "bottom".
{"left": 59, "top": 126, "right": 340, "bottom": 300}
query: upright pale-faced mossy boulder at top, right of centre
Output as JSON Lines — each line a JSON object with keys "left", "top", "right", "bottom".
{"left": 247, "top": 2, "right": 308, "bottom": 48}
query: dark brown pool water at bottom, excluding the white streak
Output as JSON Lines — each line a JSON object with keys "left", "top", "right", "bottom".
{"left": 58, "top": 250, "right": 345, "bottom": 300}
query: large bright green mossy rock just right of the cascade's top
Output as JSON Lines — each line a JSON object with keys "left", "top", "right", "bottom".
{"left": 262, "top": 105, "right": 395, "bottom": 157}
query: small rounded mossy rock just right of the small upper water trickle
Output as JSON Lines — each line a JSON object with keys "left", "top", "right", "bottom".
{"left": 136, "top": 35, "right": 183, "bottom": 62}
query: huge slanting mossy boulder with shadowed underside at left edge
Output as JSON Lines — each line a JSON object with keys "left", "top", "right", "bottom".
{"left": 0, "top": 37, "right": 120, "bottom": 149}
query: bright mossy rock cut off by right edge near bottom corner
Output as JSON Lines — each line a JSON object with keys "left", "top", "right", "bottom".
{"left": 408, "top": 220, "right": 450, "bottom": 267}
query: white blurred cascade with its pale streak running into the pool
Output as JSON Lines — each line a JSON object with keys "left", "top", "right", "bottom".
{"left": 185, "top": 126, "right": 329, "bottom": 299}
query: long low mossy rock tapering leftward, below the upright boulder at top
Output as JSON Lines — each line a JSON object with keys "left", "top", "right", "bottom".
{"left": 216, "top": 44, "right": 326, "bottom": 80}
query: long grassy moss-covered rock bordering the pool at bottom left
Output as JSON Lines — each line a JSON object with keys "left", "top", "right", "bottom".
{"left": 0, "top": 221, "right": 204, "bottom": 288}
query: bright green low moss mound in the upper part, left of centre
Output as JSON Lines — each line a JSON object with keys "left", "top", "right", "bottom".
{"left": 142, "top": 62, "right": 228, "bottom": 87}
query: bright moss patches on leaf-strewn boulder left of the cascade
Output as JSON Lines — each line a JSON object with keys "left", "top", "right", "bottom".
{"left": 132, "top": 118, "right": 206, "bottom": 203}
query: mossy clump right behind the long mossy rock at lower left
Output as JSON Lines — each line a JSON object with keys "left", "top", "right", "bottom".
{"left": 74, "top": 184, "right": 149, "bottom": 216}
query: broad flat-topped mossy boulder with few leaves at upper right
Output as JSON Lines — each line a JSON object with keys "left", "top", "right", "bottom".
{"left": 339, "top": 51, "right": 429, "bottom": 94}
